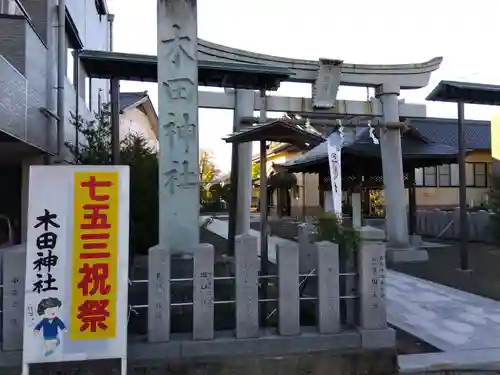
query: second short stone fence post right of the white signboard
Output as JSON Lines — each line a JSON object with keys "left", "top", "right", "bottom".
{"left": 193, "top": 244, "right": 215, "bottom": 340}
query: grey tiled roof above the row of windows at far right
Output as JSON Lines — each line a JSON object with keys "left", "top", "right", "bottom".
{"left": 410, "top": 117, "right": 491, "bottom": 150}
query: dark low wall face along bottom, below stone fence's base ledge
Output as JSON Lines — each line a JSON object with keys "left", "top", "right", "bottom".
{"left": 2, "top": 350, "right": 397, "bottom": 375}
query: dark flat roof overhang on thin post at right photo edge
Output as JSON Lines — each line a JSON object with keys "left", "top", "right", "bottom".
{"left": 426, "top": 81, "right": 500, "bottom": 105}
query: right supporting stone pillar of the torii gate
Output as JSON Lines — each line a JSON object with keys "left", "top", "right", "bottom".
{"left": 376, "top": 84, "right": 409, "bottom": 249}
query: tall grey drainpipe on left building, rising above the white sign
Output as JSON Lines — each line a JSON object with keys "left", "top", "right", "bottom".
{"left": 57, "top": 0, "right": 66, "bottom": 163}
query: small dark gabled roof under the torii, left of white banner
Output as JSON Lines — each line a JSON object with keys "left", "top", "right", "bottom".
{"left": 225, "top": 119, "right": 324, "bottom": 146}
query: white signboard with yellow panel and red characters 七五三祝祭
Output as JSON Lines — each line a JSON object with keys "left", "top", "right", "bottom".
{"left": 23, "top": 166, "right": 129, "bottom": 373}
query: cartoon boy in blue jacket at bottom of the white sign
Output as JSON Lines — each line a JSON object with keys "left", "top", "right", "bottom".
{"left": 34, "top": 297, "right": 67, "bottom": 356}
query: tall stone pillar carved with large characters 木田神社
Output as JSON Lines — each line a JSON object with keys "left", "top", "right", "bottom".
{"left": 157, "top": 0, "right": 200, "bottom": 253}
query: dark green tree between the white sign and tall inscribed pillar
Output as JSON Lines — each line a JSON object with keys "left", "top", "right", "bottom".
{"left": 66, "top": 104, "right": 158, "bottom": 261}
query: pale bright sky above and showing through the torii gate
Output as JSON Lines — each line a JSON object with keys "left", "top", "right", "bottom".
{"left": 108, "top": 0, "right": 500, "bottom": 171}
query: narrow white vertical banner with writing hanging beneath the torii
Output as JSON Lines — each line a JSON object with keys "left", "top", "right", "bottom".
{"left": 327, "top": 132, "right": 342, "bottom": 217}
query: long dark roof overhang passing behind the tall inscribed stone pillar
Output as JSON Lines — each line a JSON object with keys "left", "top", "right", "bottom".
{"left": 80, "top": 50, "right": 292, "bottom": 90}
